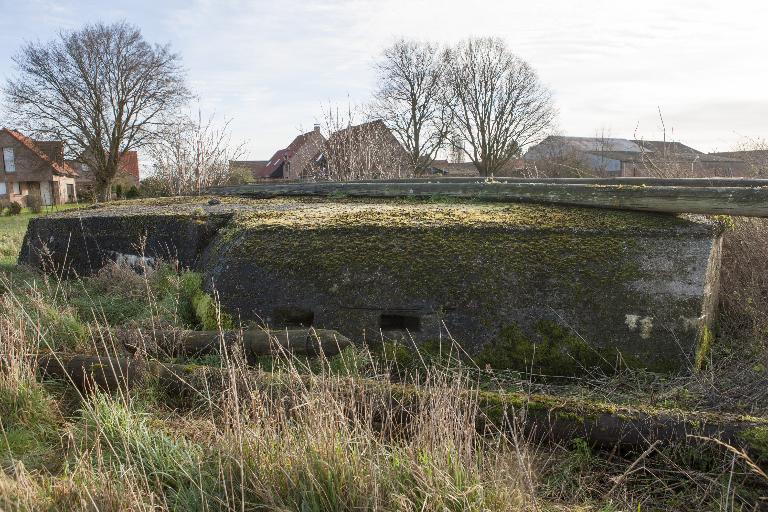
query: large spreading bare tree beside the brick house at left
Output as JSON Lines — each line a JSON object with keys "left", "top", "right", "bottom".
{"left": 5, "top": 22, "right": 188, "bottom": 199}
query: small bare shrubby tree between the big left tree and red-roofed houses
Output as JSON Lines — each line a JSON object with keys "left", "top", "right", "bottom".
{"left": 150, "top": 109, "right": 245, "bottom": 195}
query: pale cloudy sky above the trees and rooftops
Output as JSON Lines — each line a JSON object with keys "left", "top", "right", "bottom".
{"left": 0, "top": 0, "right": 768, "bottom": 159}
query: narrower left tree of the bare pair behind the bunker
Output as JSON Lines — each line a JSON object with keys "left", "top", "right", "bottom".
{"left": 372, "top": 39, "right": 450, "bottom": 174}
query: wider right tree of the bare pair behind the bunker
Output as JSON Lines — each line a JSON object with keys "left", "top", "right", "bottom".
{"left": 445, "top": 38, "right": 556, "bottom": 176}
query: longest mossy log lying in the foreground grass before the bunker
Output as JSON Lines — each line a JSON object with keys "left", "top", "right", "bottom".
{"left": 38, "top": 355, "right": 768, "bottom": 450}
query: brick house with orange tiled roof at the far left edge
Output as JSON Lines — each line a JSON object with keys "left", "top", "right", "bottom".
{"left": 0, "top": 128, "right": 78, "bottom": 205}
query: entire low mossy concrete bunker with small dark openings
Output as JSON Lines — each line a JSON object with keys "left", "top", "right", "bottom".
{"left": 21, "top": 199, "right": 720, "bottom": 374}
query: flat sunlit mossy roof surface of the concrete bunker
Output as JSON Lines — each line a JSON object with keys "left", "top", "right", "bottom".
{"left": 57, "top": 197, "right": 716, "bottom": 234}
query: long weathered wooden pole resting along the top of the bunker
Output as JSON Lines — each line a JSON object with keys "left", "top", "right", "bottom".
{"left": 209, "top": 178, "right": 768, "bottom": 217}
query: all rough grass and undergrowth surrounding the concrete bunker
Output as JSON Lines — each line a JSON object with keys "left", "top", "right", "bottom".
{"left": 0, "top": 205, "right": 766, "bottom": 511}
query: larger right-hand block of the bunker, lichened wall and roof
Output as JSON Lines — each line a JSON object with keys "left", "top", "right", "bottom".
{"left": 196, "top": 197, "right": 718, "bottom": 373}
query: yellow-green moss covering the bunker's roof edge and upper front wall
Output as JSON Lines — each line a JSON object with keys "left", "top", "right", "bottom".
{"left": 220, "top": 204, "right": 672, "bottom": 297}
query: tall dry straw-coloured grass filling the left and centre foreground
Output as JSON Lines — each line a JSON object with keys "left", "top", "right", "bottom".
{"left": 0, "top": 269, "right": 538, "bottom": 511}
